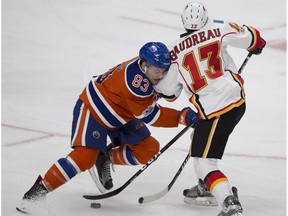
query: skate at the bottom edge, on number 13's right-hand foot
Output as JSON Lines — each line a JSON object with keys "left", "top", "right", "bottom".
{"left": 218, "top": 195, "right": 243, "bottom": 216}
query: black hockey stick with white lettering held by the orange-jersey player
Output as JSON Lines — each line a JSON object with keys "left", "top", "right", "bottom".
{"left": 83, "top": 123, "right": 194, "bottom": 200}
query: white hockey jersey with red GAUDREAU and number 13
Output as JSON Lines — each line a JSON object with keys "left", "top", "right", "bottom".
{"left": 154, "top": 20, "right": 261, "bottom": 119}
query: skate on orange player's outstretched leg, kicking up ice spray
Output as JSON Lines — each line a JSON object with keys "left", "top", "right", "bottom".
{"left": 16, "top": 175, "right": 49, "bottom": 213}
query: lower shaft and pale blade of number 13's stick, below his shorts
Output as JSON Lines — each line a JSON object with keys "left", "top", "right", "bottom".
{"left": 138, "top": 154, "right": 190, "bottom": 204}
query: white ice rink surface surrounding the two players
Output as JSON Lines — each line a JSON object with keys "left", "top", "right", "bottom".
{"left": 1, "top": 0, "right": 286, "bottom": 216}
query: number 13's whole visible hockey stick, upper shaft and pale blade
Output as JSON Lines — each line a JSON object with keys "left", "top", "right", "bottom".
{"left": 138, "top": 52, "right": 252, "bottom": 204}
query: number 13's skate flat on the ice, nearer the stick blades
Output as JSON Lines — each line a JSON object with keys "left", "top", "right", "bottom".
{"left": 183, "top": 179, "right": 218, "bottom": 206}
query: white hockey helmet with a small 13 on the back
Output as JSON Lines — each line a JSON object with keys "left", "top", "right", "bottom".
{"left": 181, "top": 1, "right": 208, "bottom": 30}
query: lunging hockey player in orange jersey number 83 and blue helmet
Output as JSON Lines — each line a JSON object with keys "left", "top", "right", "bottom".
{"left": 17, "top": 42, "right": 199, "bottom": 212}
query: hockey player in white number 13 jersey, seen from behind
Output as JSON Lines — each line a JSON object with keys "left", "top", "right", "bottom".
{"left": 155, "top": 2, "right": 266, "bottom": 216}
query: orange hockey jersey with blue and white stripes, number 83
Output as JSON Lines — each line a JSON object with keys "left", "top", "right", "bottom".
{"left": 80, "top": 57, "right": 179, "bottom": 130}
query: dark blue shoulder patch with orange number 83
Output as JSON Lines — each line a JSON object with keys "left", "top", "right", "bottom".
{"left": 125, "top": 60, "right": 153, "bottom": 97}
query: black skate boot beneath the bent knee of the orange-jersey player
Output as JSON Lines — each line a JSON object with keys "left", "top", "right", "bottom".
{"left": 96, "top": 153, "right": 113, "bottom": 190}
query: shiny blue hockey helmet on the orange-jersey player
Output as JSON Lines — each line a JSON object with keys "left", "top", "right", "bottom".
{"left": 139, "top": 42, "right": 171, "bottom": 69}
